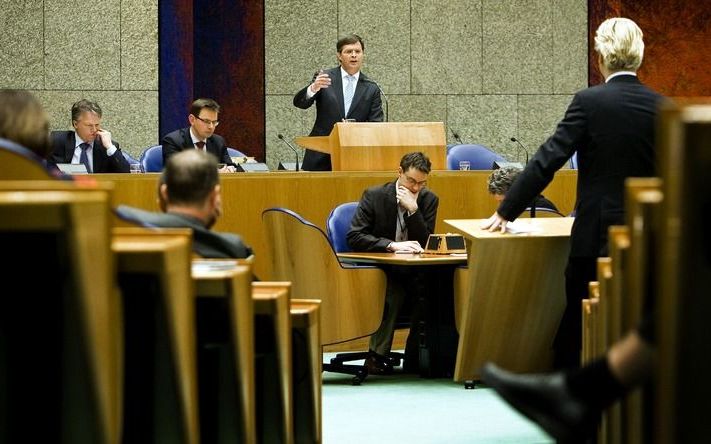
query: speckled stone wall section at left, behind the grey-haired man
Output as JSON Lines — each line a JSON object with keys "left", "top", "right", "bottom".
{"left": 0, "top": 0, "right": 158, "bottom": 160}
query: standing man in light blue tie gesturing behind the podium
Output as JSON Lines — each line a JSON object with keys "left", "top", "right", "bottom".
{"left": 294, "top": 34, "right": 383, "bottom": 171}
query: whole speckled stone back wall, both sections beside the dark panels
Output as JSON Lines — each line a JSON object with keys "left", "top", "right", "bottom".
{"left": 0, "top": 0, "right": 587, "bottom": 168}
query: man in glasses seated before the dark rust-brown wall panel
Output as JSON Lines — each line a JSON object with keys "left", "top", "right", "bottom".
{"left": 161, "top": 99, "right": 237, "bottom": 173}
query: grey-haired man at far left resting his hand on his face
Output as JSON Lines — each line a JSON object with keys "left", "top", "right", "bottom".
{"left": 47, "top": 99, "right": 129, "bottom": 173}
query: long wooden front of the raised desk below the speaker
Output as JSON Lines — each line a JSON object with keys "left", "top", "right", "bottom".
{"left": 97, "top": 170, "right": 577, "bottom": 279}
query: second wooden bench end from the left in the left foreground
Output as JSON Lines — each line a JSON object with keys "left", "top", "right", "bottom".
{"left": 111, "top": 228, "right": 200, "bottom": 443}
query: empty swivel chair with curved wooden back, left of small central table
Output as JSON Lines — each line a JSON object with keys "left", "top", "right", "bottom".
{"left": 262, "top": 208, "right": 386, "bottom": 385}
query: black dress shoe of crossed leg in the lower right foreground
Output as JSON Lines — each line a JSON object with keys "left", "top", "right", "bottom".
{"left": 481, "top": 363, "right": 601, "bottom": 443}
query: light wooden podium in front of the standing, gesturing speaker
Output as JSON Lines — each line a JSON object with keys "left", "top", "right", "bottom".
{"left": 295, "top": 122, "right": 447, "bottom": 171}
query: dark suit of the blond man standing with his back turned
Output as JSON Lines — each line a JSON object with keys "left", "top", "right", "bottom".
{"left": 498, "top": 75, "right": 662, "bottom": 367}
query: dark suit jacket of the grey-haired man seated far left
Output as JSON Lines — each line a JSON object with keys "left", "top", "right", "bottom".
{"left": 47, "top": 131, "right": 130, "bottom": 173}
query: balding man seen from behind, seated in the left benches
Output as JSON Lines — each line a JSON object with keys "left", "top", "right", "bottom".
{"left": 117, "top": 150, "right": 252, "bottom": 259}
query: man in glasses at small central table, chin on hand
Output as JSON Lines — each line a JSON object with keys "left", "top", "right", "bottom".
{"left": 347, "top": 152, "right": 439, "bottom": 374}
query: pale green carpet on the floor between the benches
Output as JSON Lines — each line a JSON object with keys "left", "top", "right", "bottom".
{"left": 323, "top": 356, "right": 553, "bottom": 444}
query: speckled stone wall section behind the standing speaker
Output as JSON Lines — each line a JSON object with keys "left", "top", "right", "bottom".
{"left": 265, "top": 0, "right": 587, "bottom": 169}
